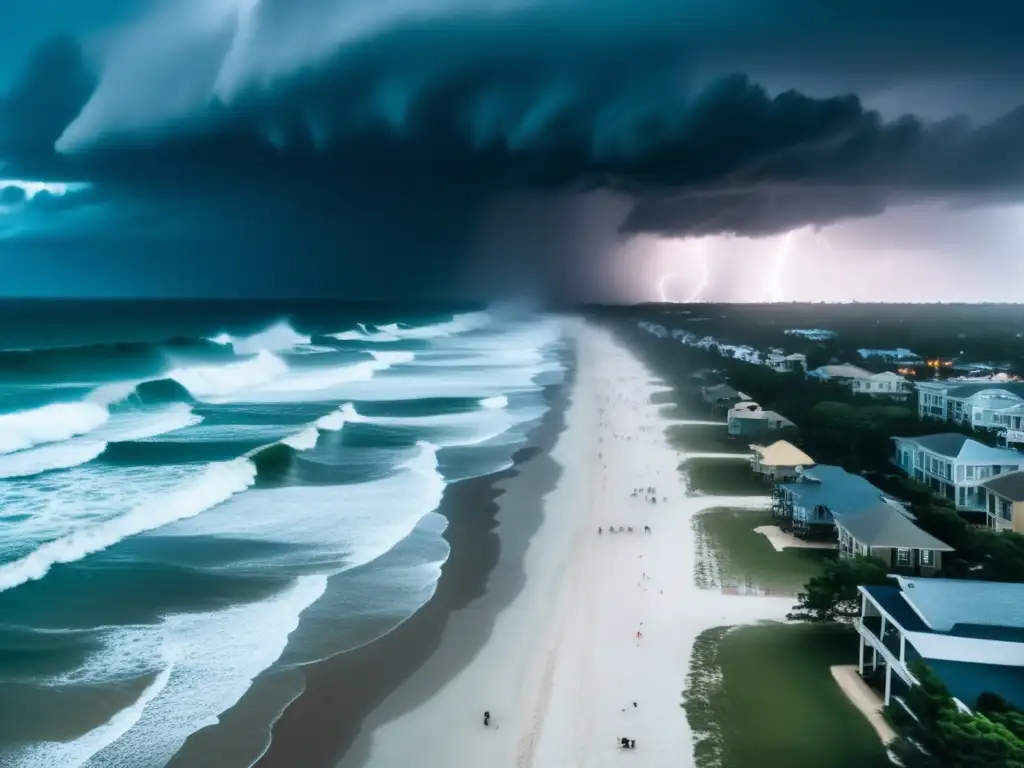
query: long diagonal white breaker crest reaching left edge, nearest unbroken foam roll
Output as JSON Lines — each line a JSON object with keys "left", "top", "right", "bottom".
{"left": 0, "top": 459, "right": 256, "bottom": 592}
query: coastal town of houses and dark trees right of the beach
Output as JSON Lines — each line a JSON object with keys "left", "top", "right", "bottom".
{"left": 634, "top": 316, "right": 1024, "bottom": 766}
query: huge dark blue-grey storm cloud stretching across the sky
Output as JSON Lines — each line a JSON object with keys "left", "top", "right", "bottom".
{"left": 6, "top": 0, "right": 1024, "bottom": 296}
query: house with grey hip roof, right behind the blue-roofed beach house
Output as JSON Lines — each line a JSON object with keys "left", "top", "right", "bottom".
{"left": 836, "top": 500, "right": 953, "bottom": 577}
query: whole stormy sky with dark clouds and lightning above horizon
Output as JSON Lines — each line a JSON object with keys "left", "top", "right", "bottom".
{"left": 0, "top": 0, "right": 1024, "bottom": 302}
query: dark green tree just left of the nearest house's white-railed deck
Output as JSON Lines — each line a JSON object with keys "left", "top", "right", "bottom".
{"left": 786, "top": 557, "right": 890, "bottom": 622}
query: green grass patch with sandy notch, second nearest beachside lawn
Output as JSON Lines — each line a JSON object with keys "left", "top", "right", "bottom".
{"left": 693, "top": 508, "right": 836, "bottom": 595}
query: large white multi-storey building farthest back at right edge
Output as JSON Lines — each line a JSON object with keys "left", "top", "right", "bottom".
{"left": 916, "top": 377, "right": 1024, "bottom": 430}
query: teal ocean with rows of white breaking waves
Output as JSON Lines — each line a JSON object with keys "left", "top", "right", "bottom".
{"left": 0, "top": 301, "right": 566, "bottom": 768}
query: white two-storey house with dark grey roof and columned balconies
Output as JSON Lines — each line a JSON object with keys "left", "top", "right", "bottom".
{"left": 893, "top": 432, "right": 1024, "bottom": 512}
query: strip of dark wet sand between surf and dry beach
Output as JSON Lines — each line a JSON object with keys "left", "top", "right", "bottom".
{"left": 244, "top": 354, "right": 575, "bottom": 768}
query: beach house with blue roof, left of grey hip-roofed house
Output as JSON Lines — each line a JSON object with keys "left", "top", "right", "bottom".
{"left": 772, "top": 464, "right": 887, "bottom": 539}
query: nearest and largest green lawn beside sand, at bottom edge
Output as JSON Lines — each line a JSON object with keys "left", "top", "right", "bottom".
{"left": 682, "top": 624, "right": 890, "bottom": 768}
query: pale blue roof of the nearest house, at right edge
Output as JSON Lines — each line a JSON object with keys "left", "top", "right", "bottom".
{"left": 895, "top": 577, "right": 1024, "bottom": 642}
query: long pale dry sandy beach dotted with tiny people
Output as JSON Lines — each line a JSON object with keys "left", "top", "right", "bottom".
{"left": 341, "top": 321, "right": 793, "bottom": 768}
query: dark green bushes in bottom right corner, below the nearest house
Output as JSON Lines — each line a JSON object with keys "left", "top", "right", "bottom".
{"left": 887, "top": 664, "right": 1024, "bottom": 768}
